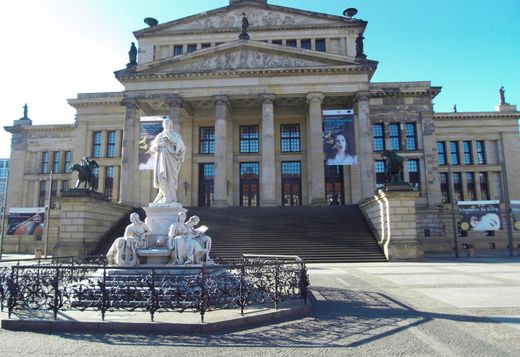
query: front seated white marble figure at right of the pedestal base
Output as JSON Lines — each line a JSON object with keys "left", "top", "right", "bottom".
{"left": 168, "top": 212, "right": 207, "bottom": 265}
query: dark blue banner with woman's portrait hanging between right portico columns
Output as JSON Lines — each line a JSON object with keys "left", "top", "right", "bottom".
{"left": 323, "top": 109, "right": 357, "bottom": 166}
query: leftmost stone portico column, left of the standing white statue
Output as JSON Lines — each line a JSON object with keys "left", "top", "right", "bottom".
{"left": 119, "top": 99, "right": 137, "bottom": 204}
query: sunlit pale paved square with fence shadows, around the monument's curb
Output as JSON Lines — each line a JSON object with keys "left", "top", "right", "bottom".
{"left": 0, "top": 258, "right": 520, "bottom": 357}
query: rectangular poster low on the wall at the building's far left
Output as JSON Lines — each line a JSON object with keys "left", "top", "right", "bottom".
{"left": 7, "top": 207, "right": 45, "bottom": 240}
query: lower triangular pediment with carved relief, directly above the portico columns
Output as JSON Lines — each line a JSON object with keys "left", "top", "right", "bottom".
{"left": 134, "top": 40, "right": 359, "bottom": 75}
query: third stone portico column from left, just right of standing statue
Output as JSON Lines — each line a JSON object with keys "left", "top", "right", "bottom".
{"left": 213, "top": 95, "right": 229, "bottom": 207}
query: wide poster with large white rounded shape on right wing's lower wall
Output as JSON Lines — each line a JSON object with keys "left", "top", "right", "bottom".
{"left": 457, "top": 201, "right": 501, "bottom": 231}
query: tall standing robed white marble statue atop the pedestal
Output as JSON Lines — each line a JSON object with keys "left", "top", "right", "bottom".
{"left": 150, "top": 117, "right": 186, "bottom": 204}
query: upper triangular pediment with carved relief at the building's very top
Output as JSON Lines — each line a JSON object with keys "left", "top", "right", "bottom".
{"left": 134, "top": 2, "right": 359, "bottom": 38}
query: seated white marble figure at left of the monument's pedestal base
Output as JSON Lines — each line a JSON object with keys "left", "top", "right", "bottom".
{"left": 107, "top": 213, "right": 152, "bottom": 266}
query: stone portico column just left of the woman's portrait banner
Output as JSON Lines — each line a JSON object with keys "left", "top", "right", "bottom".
{"left": 307, "top": 93, "right": 325, "bottom": 205}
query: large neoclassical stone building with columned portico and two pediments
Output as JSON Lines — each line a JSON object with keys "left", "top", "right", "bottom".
{"left": 5, "top": 0, "right": 520, "bottom": 252}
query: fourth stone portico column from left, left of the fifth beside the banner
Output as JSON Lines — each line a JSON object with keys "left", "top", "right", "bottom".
{"left": 260, "top": 94, "right": 276, "bottom": 206}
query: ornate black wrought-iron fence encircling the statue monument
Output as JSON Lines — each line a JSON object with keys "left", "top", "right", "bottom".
{"left": 0, "top": 256, "right": 309, "bottom": 322}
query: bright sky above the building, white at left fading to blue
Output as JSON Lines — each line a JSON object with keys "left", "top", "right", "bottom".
{"left": 0, "top": 0, "right": 520, "bottom": 157}
